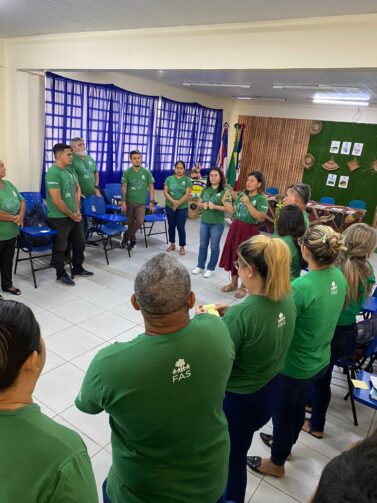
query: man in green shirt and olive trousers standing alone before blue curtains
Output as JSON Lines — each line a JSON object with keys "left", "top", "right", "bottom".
{"left": 120, "top": 150, "right": 154, "bottom": 250}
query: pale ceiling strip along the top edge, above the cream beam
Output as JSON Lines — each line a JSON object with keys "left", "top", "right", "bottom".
{"left": 0, "top": 0, "right": 377, "bottom": 38}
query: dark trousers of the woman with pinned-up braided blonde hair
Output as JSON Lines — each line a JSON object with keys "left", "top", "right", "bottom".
{"left": 271, "top": 366, "right": 327, "bottom": 466}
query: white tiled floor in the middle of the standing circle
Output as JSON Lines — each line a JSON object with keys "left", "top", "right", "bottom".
{"left": 6, "top": 220, "right": 377, "bottom": 503}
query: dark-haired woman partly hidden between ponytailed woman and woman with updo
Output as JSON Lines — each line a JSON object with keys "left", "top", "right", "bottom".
{"left": 276, "top": 204, "right": 305, "bottom": 279}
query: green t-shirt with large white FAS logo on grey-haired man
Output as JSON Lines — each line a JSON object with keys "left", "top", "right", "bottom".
{"left": 76, "top": 314, "right": 234, "bottom": 503}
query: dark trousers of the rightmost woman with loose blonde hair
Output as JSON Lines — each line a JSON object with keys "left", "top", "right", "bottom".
{"left": 310, "top": 323, "right": 357, "bottom": 432}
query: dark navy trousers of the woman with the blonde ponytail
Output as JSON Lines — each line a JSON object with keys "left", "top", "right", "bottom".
{"left": 224, "top": 374, "right": 282, "bottom": 503}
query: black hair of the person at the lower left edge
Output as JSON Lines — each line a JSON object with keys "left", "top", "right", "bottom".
{"left": 0, "top": 300, "right": 41, "bottom": 391}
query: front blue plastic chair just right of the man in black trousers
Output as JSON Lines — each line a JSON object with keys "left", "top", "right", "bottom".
{"left": 84, "top": 196, "right": 131, "bottom": 265}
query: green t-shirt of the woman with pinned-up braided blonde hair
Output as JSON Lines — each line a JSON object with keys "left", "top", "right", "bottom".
{"left": 283, "top": 266, "right": 347, "bottom": 379}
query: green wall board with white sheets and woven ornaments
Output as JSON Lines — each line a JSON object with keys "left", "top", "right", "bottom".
{"left": 303, "top": 122, "right": 377, "bottom": 224}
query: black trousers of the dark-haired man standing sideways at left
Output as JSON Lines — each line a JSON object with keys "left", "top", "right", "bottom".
{"left": 47, "top": 218, "right": 85, "bottom": 279}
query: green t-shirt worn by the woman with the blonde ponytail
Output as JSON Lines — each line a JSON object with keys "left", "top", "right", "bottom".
{"left": 223, "top": 295, "right": 296, "bottom": 393}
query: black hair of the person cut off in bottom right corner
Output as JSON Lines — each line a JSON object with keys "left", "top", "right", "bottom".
{"left": 312, "top": 431, "right": 377, "bottom": 503}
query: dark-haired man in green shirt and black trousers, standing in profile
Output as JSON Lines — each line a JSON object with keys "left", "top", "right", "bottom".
{"left": 45, "top": 143, "right": 93, "bottom": 286}
